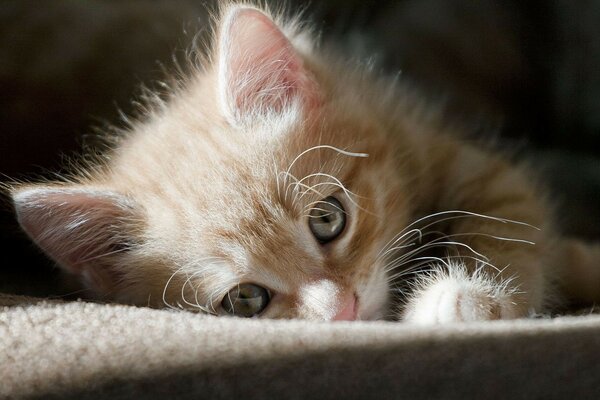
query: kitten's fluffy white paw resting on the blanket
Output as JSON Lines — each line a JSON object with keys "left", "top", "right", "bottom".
{"left": 401, "top": 268, "right": 518, "bottom": 325}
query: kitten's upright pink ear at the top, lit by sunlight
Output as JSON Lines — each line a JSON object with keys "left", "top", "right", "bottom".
{"left": 217, "top": 7, "right": 319, "bottom": 125}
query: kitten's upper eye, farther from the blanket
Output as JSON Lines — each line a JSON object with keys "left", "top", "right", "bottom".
{"left": 308, "top": 196, "right": 346, "bottom": 244}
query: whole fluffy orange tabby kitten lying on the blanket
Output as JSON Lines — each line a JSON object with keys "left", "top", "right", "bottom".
{"left": 5, "top": 3, "right": 600, "bottom": 324}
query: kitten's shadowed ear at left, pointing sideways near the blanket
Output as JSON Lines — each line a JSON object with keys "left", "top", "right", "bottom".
{"left": 12, "top": 187, "right": 139, "bottom": 293}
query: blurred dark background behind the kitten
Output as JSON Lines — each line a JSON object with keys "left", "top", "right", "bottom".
{"left": 0, "top": 0, "right": 600, "bottom": 296}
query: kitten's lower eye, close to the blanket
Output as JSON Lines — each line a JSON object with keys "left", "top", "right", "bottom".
{"left": 221, "top": 283, "right": 271, "bottom": 318}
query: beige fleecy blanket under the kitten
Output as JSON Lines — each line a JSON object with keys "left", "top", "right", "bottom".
{"left": 0, "top": 295, "right": 600, "bottom": 400}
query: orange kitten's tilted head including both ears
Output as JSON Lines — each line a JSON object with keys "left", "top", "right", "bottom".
{"left": 12, "top": 6, "right": 406, "bottom": 320}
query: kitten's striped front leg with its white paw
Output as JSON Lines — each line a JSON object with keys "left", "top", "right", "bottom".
{"left": 401, "top": 143, "right": 554, "bottom": 323}
